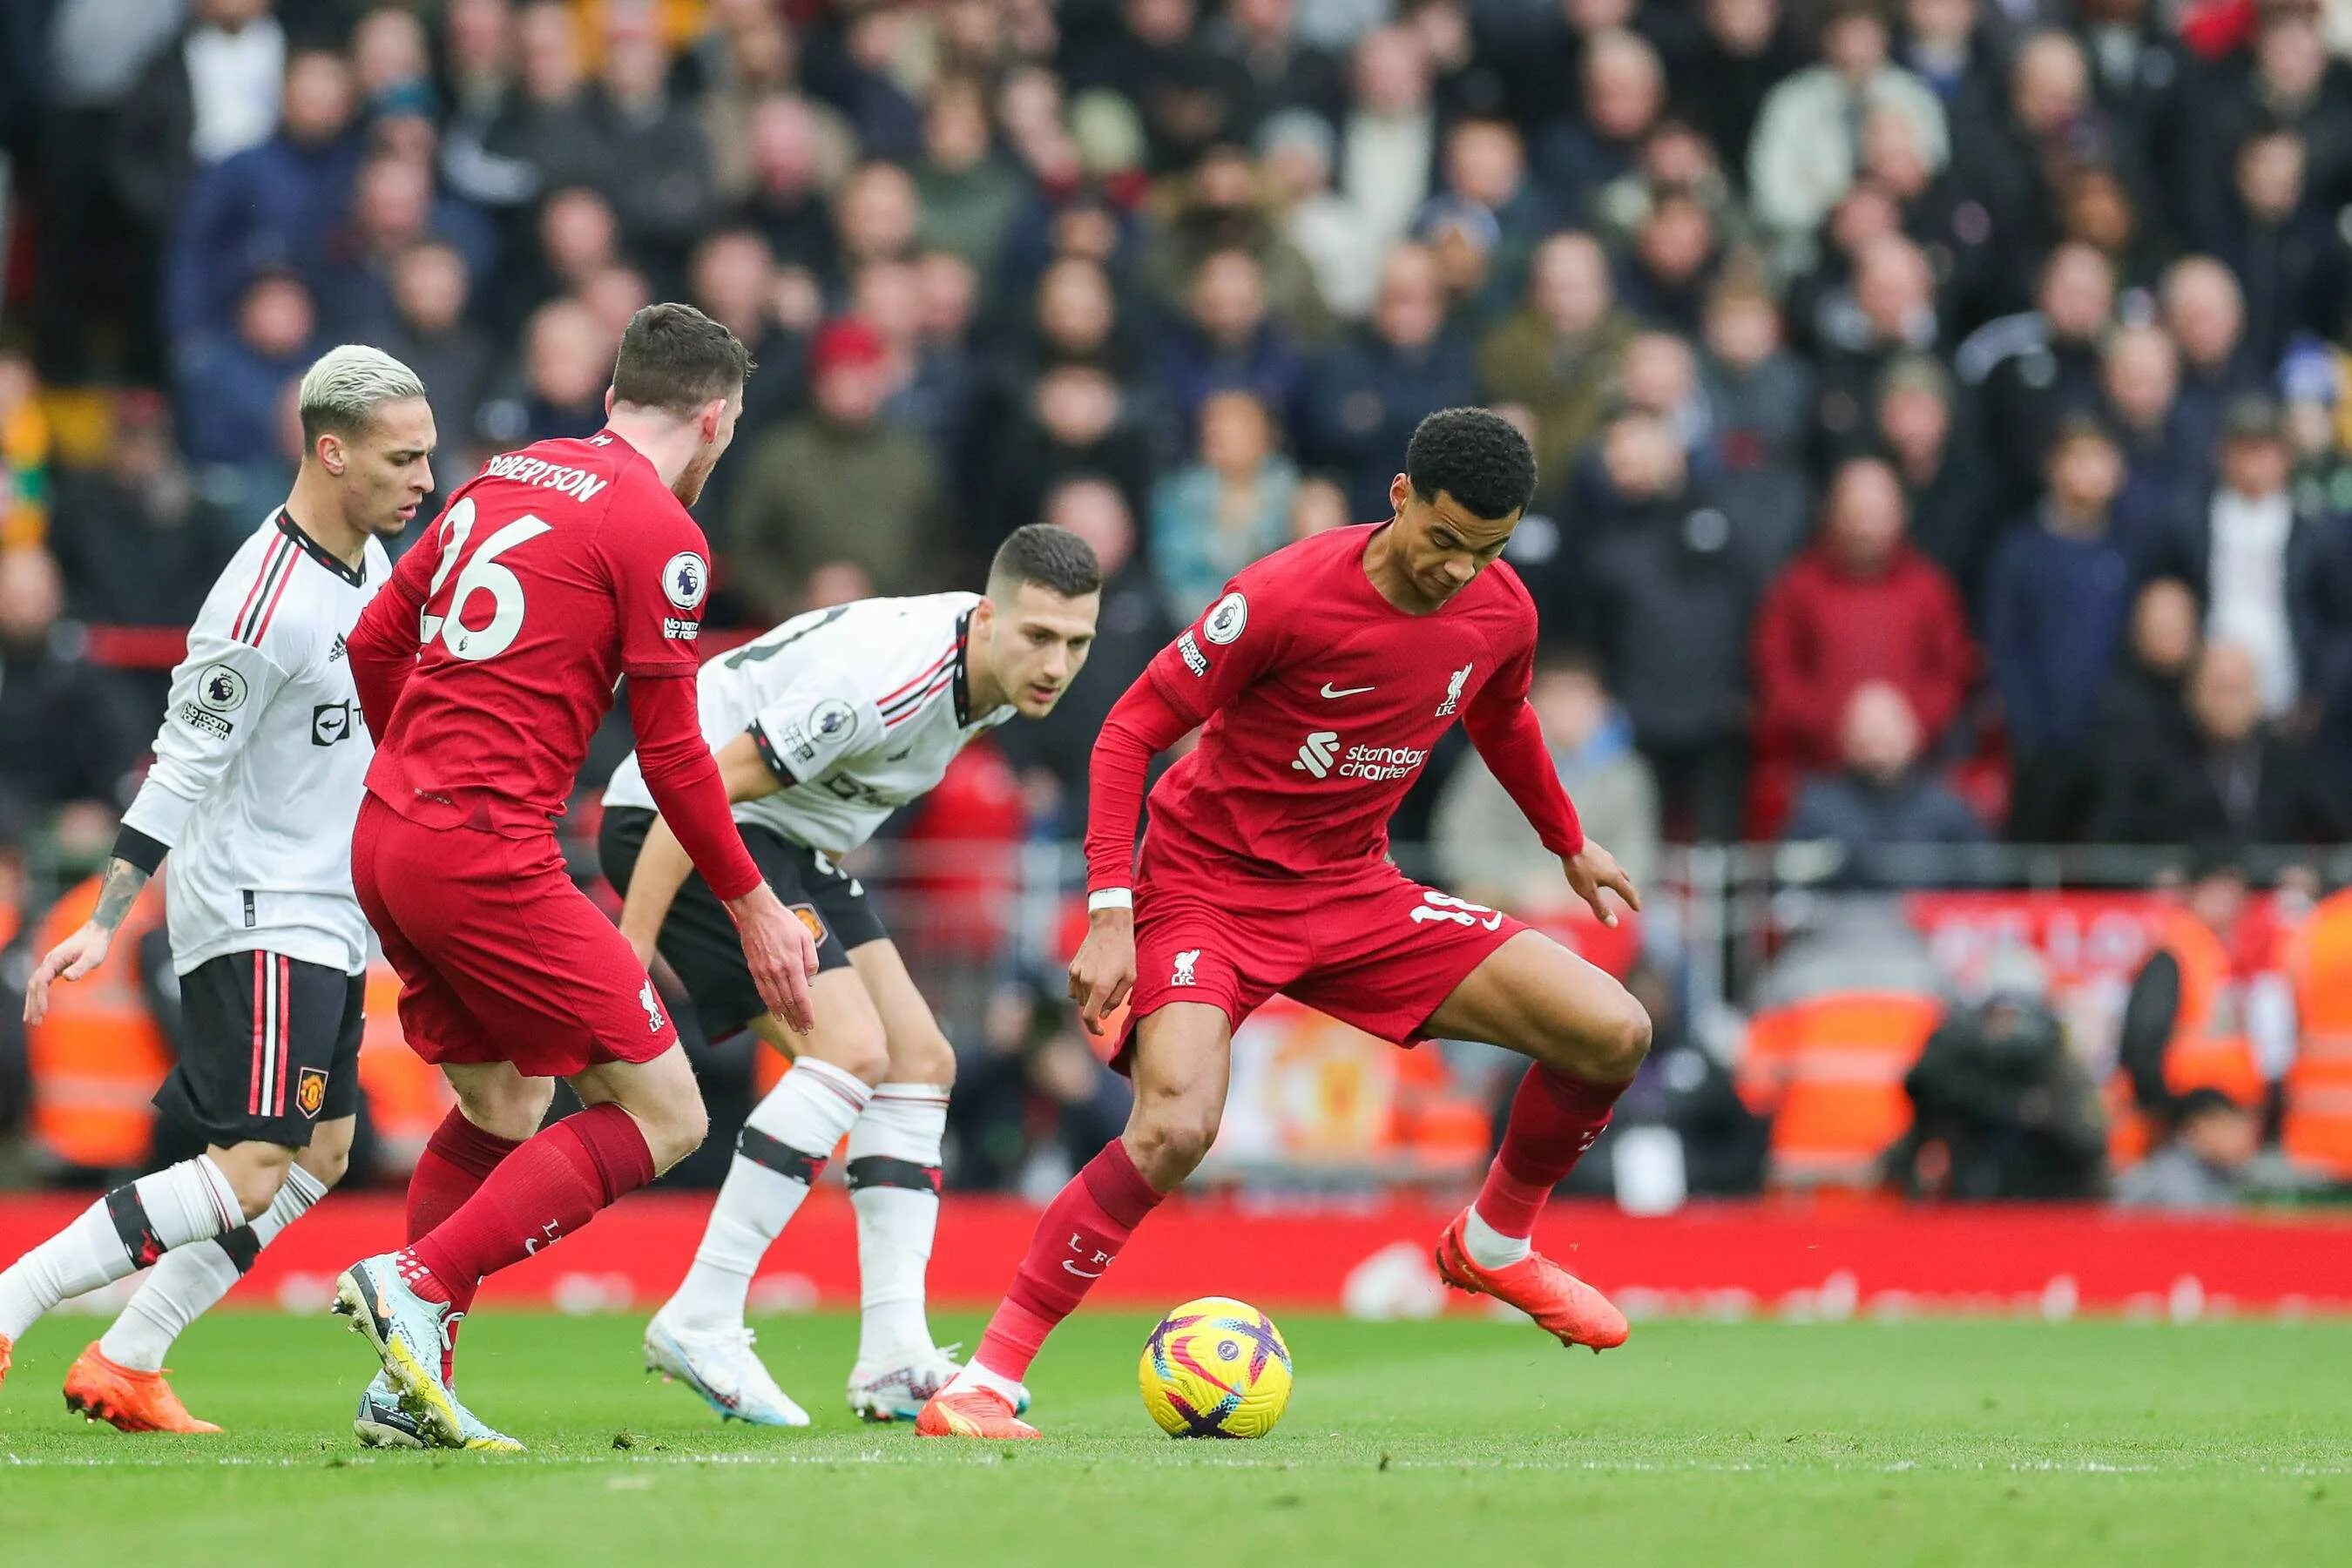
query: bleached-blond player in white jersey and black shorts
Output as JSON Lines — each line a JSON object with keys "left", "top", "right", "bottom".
{"left": 0, "top": 346, "right": 433, "bottom": 1431}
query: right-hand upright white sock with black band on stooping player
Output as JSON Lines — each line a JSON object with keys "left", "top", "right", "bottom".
{"left": 849, "top": 1084, "right": 948, "bottom": 1370}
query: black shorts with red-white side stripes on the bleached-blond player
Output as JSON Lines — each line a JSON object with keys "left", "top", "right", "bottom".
{"left": 155, "top": 952, "right": 367, "bottom": 1150}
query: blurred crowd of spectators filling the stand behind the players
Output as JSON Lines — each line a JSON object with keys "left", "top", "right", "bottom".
{"left": 0, "top": 0, "right": 2352, "bottom": 1203}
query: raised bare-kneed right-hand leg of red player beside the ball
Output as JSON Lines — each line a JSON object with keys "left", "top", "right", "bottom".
{"left": 1428, "top": 931, "right": 1649, "bottom": 1349}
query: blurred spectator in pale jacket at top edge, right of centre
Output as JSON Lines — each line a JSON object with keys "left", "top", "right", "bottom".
{"left": 1747, "top": 0, "right": 1948, "bottom": 260}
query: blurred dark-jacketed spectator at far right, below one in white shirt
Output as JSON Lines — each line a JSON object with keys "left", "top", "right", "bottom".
{"left": 2091, "top": 642, "right": 2352, "bottom": 844}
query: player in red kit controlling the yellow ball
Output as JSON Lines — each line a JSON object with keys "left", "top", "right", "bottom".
{"left": 915, "top": 409, "right": 1649, "bottom": 1439}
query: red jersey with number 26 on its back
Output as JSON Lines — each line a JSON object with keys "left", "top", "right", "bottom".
{"left": 350, "top": 430, "right": 710, "bottom": 835}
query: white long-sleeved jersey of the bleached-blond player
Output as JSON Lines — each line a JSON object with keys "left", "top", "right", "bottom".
{"left": 122, "top": 508, "right": 390, "bottom": 973}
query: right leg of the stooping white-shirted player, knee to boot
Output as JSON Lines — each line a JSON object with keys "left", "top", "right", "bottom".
{"left": 849, "top": 938, "right": 960, "bottom": 1420}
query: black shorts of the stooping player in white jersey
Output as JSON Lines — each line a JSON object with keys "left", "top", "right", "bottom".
{"left": 595, "top": 807, "right": 889, "bottom": 1042}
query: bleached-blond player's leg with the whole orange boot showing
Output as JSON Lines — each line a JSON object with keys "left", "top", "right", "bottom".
{"left": 64, "top": 1117, "right": 357, "bottom": 1431}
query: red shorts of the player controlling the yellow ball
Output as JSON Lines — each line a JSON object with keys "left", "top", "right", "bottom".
{"left": 1119, "top": 837, "right": 1526, "bottom": 1064}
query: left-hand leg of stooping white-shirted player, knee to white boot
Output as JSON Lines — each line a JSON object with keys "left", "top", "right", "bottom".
{"left": 645, "top": 987, "right": 887, "bottom": 1427}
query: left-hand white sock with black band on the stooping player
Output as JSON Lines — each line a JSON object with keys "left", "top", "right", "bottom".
{"left": 663, "top": 1058, "right": 873, "bottom": 1328}
